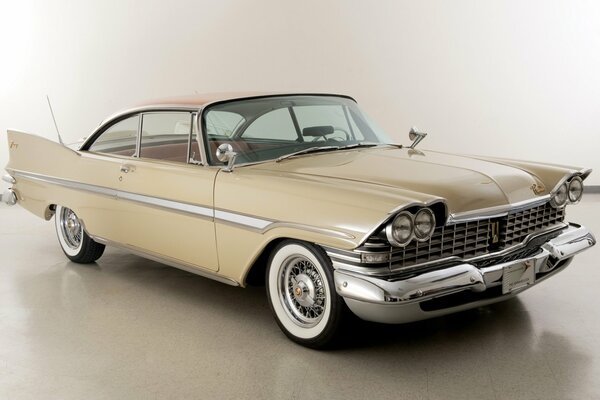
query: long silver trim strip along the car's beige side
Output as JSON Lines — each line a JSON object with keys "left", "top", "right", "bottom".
{"left": 13, "top": 170, "right": 354, "bottom": 239}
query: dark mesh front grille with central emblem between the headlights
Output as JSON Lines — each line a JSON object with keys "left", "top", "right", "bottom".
{"left": 359, "top": 203, "right": 565, "bottom": 269}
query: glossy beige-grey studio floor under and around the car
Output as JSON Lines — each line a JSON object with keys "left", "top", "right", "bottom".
{"left": 0, "top": 195, "right": 600, "bottom": 400}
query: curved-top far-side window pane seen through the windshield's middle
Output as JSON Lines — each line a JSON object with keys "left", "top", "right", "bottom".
{"left": 242, "top": 108, "right": 298, "bottom": 140}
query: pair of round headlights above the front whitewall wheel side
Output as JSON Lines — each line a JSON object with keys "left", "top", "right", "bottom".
{"left": 385, "top": 207, "right": 435, "bottom": 247}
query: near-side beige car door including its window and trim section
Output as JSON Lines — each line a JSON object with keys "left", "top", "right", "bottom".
{"left": 112, "top": 111, "right": 218, "bottom": 271}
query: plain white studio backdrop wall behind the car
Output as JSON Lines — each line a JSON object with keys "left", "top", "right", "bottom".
{"left": 0, "top": 0, "right": 600, "bottom": 185}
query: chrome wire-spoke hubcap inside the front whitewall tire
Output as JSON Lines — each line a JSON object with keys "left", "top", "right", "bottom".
{"left": 279, "top": 256, "right": 327, "bottom": 328}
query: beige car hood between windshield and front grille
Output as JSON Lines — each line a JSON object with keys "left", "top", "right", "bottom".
{"left": 254, "top": 147, "right": 551, "bottom": 213}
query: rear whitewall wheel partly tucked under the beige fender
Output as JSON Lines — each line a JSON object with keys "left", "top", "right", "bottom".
{"left": 54, "top": 206, "right": 104, "bottom": 264}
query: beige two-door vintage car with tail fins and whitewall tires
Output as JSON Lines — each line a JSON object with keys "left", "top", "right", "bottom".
{"left": 2, "top": 94, "right": 596, "bottom": 348}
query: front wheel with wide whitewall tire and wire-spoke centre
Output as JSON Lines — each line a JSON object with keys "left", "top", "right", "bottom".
{"left": 266, "top": 240, "right": 345, "bottom": 348}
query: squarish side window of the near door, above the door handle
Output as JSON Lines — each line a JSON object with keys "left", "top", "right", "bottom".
{"left": 140, "top": 112, "right": 192, "bottom": 163}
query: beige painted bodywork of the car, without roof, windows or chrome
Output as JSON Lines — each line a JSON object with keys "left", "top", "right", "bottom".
{"left": 7, "top": 114, "right": 586, "bottom": 285}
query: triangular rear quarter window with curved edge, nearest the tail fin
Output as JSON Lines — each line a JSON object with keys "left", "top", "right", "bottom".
{"left": 89, "top": 115, "right": 140, "bottom": 156}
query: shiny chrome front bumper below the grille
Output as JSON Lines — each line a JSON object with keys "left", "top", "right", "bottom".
{"left": 334, "top": 224, "right": 596, "bottom": 323}
